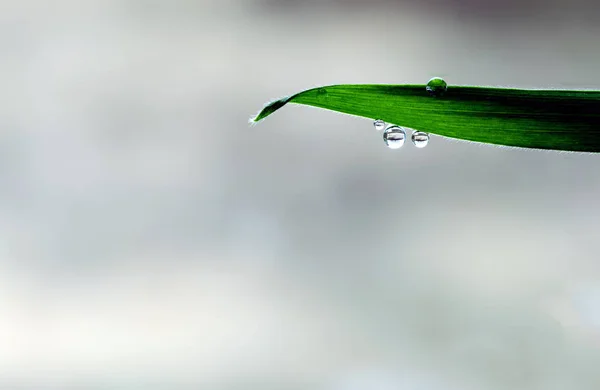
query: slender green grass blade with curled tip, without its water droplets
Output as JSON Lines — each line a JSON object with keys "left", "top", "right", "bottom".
{"left": 253, "top": 84, "right": 600, "bottom": 152}
